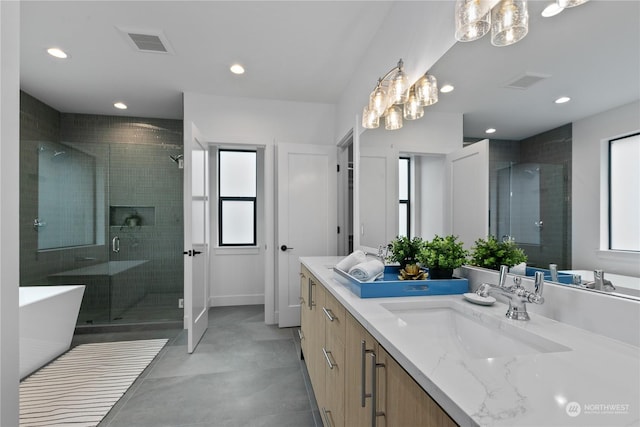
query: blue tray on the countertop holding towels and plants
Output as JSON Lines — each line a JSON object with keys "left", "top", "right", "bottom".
{"left": 333, "top": 265, "right": 469, "bottom": 298}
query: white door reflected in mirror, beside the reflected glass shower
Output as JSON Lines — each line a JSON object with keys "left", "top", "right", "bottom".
{"left": 445, "top": 139, "right": 489, "bottom": 249}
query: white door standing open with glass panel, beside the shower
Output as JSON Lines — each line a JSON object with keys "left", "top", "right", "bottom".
{"left": 184, "top": 125, "right": 209, "bottom": 353}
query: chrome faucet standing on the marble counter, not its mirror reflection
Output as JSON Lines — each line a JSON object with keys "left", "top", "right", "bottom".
{"left": 476, "top": 265, "right": 544, "bottom": 320}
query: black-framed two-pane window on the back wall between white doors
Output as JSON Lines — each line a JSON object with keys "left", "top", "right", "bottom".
{"left": 218, "top": 149, "right": 257, "bottom": 247}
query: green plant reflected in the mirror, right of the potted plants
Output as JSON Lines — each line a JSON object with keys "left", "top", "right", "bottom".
{"left": 471, "top": 236, "right": 527, "bottom": 270}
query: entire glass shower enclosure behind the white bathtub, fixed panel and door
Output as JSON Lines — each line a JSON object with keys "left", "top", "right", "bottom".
{"left": 21, "top": 141, "right": 183, "bottom": 327}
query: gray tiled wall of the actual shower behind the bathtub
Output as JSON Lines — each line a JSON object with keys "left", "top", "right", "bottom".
{"left": 20, "top": 92, "right": 183, "bottom": 324}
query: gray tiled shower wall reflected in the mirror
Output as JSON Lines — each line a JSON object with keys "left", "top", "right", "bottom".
{"left": 489, "top": 124, "right": 572, "bottom": 269}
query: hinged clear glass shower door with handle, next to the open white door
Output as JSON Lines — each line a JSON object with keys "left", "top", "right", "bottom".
{"left": 108, "top": 144, "right": 183, "bottom": 323}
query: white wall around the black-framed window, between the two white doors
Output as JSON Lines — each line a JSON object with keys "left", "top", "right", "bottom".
{"left": 183, "top": 93, "right": 339, "bottom": 323}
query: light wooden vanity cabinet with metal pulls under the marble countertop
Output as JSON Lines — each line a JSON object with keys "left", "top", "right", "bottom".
{"left": 300, "top": 266, "right": 456, "bottom": 427}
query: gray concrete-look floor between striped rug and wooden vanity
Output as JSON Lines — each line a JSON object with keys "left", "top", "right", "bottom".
{"left": 72, "top": 305, "right": 322, "bottom": 427}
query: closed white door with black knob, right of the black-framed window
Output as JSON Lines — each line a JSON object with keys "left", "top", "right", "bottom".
{"left": 276, "top": 144, "right": 338, "bottom": 327}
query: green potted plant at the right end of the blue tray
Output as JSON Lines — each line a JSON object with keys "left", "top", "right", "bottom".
{"left": 418, "top": 235, "right": 468, "bottom": 279}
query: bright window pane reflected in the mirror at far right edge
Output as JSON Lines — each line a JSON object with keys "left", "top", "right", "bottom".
{"left": 609, "top": 134, "right": 640, "bottom": 251}
